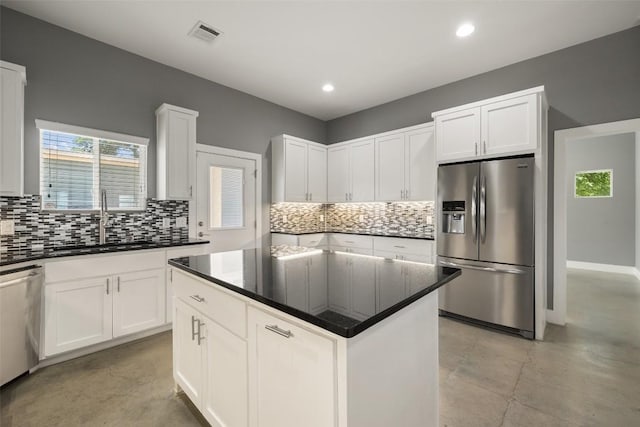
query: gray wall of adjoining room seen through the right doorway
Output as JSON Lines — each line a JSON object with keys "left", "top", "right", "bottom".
{"left": 566, "top": 133, "right": 636, "bottom": 267}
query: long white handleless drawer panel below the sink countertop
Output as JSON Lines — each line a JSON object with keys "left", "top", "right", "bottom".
{"left": 44, "top": 251, "right": 165, "bottom": 283}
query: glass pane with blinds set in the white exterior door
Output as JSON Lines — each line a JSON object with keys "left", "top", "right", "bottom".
{"left": 209, "top": 166, "right": 244, "bottom": 228}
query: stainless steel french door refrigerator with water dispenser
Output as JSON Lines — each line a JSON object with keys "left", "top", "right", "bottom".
{"left": 437, "top": 156, "right": 535, "bottom": 339}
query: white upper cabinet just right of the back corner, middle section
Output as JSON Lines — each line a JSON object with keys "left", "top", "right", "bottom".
{"left": 328, "top": 138, "right": 375, "bottom": 202}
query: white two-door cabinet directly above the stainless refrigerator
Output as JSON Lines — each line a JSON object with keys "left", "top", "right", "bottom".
{"left": 432, "top": 86, "right": 546, "bottom": 163}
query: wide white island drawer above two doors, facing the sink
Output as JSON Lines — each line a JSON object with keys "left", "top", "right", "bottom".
{"left": 173, "top": 269, "right": 247, "bottom": 338}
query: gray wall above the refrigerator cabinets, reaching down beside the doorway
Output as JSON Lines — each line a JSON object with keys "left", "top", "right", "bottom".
{"left": 327, "top": 26, "right": 640, "bottom": 308}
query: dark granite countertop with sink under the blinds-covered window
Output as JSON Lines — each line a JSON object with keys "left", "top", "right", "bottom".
{"left": 0, "top": 239, "right": 209, "bottom": 266}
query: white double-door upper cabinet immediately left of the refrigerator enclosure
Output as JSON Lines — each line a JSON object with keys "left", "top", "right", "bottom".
{"left": 375, "top": 125, "right": 436, "bottom": 202}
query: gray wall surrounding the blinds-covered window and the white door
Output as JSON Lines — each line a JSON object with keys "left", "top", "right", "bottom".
{"left": 0, "top": 7, "right": 326, "bottom": 241}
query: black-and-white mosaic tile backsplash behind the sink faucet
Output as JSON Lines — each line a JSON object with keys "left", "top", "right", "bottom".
{"left": 0, "top": 196, "right": 189, "bottom": 256}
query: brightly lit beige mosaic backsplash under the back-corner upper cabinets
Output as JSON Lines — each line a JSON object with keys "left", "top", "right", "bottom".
{"left": 270, "top": 202, "right": 435, "bottom": 237}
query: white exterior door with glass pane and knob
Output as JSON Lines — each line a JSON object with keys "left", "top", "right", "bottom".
{"left": 196, "top": 151, "right": 259, "bottom": 252}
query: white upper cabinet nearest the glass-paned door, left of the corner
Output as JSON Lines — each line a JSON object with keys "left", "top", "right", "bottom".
{"left": 271, "top": 135, "right": 327, "bottom": 203}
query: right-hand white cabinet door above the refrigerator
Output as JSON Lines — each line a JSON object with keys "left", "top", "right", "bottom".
{"left": 481, "top": 94, "right": 538, "bottom": 156}
